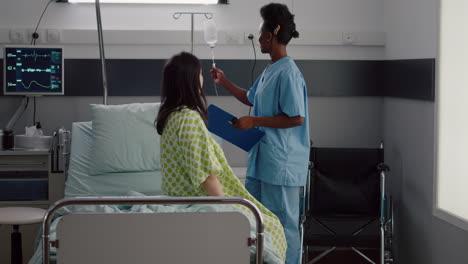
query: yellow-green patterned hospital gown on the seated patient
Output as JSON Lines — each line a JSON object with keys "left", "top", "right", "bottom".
{"left": 161, "top": 108, "right": 287, "bottom": 260}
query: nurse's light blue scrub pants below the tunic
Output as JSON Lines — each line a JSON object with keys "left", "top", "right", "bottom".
{"left": 245, "top": 177, "right": 301, "bottom": 264}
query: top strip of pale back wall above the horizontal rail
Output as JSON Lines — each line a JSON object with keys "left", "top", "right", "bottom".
{"left": 0, "top": 0, "right": 383, "bottom": 31}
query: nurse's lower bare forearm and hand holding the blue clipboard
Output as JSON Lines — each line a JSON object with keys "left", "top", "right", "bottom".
{"left": 233, "top": 114, "right": 304, "bottom": 130}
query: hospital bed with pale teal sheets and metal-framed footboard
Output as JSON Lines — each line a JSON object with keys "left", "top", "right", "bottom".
{"left": 30, "top": 122, "right": 282, "bottom": 264}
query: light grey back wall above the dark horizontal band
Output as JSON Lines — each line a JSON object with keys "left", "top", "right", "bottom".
{"left": 0, "top": 0, "right": 384, "bottom": 59}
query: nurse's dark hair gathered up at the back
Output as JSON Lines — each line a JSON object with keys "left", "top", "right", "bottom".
{"left": 260, "top": 3, "right": 299, "bottom": 45}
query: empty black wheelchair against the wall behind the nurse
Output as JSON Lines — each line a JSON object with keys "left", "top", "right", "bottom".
{"left": 299, "top": 142, "right": 394, "bottom": 264}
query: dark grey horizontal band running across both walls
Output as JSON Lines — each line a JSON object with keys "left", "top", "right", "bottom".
{"left": 0, "top": 59, "right": 435, "bottom": 101}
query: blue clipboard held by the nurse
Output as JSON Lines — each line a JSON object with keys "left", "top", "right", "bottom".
{"left": 208, "top": 104, "right": 265, "bottom": 151}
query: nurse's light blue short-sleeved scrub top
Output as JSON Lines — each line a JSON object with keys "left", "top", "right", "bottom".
{"left": 247, "top": 57, "right": 310, "bottom": 186}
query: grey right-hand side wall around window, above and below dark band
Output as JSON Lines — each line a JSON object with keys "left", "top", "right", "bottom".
{"left": 384, "top": 0, "right": 468, "bottom": 264}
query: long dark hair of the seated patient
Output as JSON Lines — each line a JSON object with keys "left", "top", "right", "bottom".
{"left": 155, "top": 52, "right": 207, "bottom": 135}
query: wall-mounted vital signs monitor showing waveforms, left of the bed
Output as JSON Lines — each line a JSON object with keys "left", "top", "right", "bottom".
{"left": 3, "top": 46, "right": 64, "bottom": 95}
